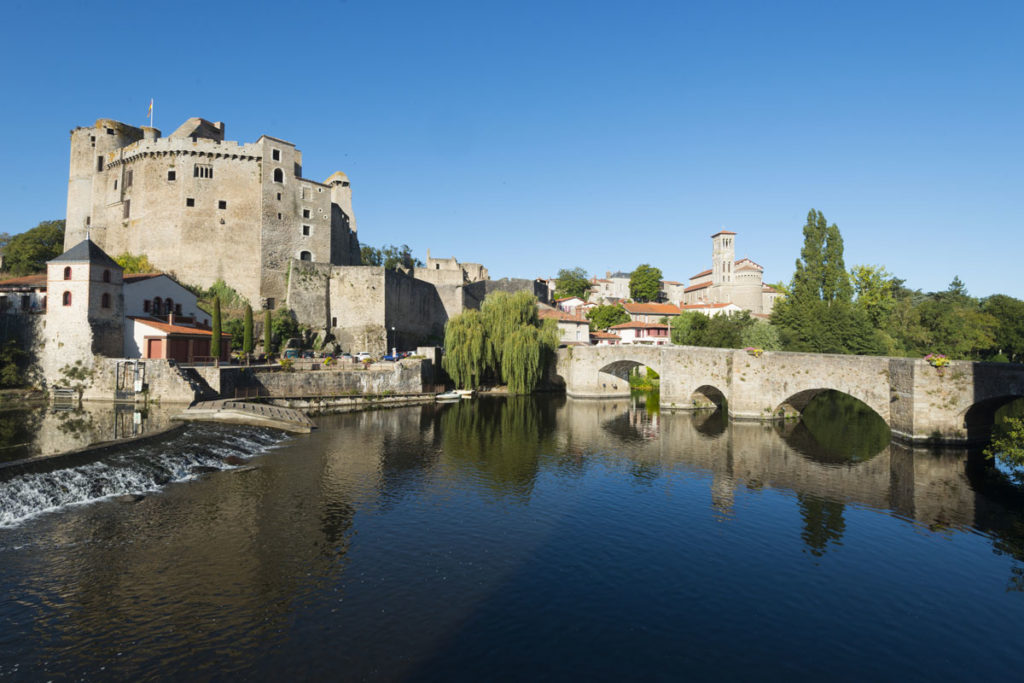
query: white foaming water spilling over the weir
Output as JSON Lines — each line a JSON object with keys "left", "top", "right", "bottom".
{"left": 0, "top": 425, "right": 285, "bottom": 527}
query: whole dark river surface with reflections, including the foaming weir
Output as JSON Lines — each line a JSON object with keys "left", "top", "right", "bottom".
{"left": 0, "top": 398, "right": 1024, "bottom": 681}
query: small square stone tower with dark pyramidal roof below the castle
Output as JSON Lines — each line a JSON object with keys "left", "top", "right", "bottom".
{"left": 42, "top": 238, "right": 125, "bottom": 377}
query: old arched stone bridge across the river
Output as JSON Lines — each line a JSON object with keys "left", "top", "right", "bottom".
{"left": 556, "top": 344, "right": 1024, "bottom": 443}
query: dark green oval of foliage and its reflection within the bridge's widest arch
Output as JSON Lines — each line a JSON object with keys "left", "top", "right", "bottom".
{"left": 780, "top": 391, "right": 892, "bottom": 465}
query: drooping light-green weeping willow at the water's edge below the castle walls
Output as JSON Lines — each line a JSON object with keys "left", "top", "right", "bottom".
{"left": 442, "top": 292, "right": 558, "bottom": 393}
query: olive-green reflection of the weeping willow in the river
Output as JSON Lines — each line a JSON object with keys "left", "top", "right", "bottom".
{"left": 440, "top": 396, "right": 556, "bottom": 496}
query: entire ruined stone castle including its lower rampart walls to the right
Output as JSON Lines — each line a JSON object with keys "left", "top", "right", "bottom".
{"left": 65, "top": 118, "right": 497, "bottom": 354}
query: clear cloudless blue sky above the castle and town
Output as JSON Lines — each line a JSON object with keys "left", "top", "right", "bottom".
{"left": 0, "top": 0, "right": 1024, "bottom": 298}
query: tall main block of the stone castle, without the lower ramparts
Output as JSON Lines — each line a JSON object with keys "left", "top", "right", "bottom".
{"left": 65, "top": 118, "right": 359, "bottom": 308}
